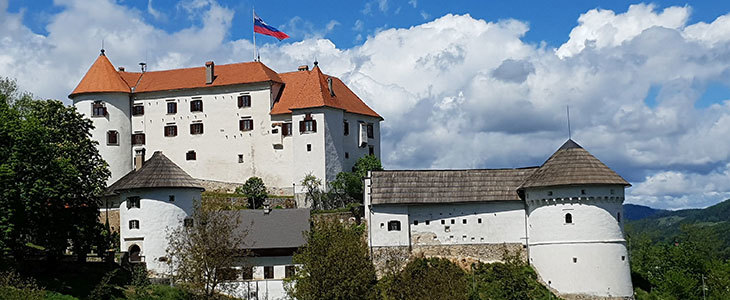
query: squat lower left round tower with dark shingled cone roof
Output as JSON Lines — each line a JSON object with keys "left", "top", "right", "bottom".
{"left": 107, "top": 151, "right": 203, "bottom": 274}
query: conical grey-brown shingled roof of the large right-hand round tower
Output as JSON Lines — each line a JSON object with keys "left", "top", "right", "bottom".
{"left": 520, "top": 139, "right": 631, "bottom": 189}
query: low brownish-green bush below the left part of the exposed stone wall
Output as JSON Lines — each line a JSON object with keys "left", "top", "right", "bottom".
{"left": 378, "top": 258, "right": 469, "bottom": 300}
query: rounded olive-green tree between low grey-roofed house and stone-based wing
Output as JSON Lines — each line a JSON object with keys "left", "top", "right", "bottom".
{"left": 286, "top": 221, "right": 376, "bottom": 300}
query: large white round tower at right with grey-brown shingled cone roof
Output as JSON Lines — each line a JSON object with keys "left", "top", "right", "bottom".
{"left": 520, "top": 140, "right": 633, "bottom": 298}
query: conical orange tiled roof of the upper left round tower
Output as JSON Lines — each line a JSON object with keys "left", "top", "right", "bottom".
{"left": 69, "top": 52, "right": 130, "bottom": 97}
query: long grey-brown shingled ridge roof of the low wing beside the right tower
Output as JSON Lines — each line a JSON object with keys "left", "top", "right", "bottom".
{"left": 370, "top": 167, "right": 536, "bottom": 204}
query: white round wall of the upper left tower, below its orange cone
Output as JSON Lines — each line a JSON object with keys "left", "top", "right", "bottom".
{"left": 72, "top": 93, "right": 132, "bottom": 185}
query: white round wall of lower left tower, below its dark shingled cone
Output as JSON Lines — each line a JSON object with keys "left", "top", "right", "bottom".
{"left": 119, "top": 188, "right": 201, "bottom": 274}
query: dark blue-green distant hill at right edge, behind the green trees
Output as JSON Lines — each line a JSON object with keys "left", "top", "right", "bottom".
{"left": 624, "top": 199, "right": 730, "bottom": 253}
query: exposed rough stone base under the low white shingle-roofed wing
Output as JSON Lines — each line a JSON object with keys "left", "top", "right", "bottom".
{"left": 371, "top": 243, "right": 527, "bottom": 277}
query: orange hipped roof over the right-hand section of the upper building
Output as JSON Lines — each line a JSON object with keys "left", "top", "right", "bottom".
{"left": 271, "top": 66, "right": 382, "bottom": 119}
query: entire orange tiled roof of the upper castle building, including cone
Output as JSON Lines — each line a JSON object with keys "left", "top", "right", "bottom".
{"left": 69, "top": 55, "right": 382, "bottom": 119}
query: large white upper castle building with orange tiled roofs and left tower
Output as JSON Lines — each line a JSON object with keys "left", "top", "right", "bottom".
{"left": 69, "top": 51, "right": 383, "bottom": 199}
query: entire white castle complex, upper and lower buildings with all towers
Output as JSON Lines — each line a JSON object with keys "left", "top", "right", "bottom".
{"left": 69, "top": 50, "right": 633, "bottom": 299}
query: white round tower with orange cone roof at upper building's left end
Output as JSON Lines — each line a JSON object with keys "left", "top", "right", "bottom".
{"left": 68, "top": 50, "right": 132, "bottom": 184}
